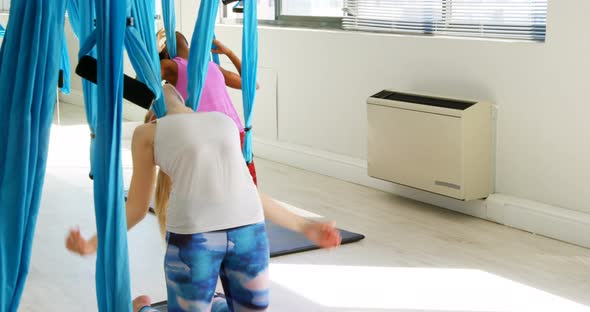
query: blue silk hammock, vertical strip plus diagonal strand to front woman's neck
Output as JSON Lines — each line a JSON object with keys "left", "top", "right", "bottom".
{"left": 75, "top": 0, "right": 165, "bottom": 311}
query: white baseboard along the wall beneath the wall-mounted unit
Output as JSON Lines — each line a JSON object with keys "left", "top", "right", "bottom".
{"left": 254, "top": 139, "right": 590, "bottom": 248}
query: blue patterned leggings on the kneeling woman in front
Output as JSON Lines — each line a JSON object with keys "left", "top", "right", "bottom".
{"left": 141, "top": 223, "right": 269, "bottom": 312}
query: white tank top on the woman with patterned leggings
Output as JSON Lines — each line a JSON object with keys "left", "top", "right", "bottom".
{"left": 154, "top": 112, "right": 264, "bottom": 234}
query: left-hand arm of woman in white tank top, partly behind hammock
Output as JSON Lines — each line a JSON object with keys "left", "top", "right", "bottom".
{"left": 66, "top": 124, "right": 156, "bottom": 255}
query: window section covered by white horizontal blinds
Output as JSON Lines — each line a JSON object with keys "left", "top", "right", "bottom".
{"left": 342, "top": 0, "right": 547, "bottom": 41}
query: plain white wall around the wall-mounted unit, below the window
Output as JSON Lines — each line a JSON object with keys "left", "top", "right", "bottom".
{"left": 194, "top": 0, "right": 590, "bottom": 218}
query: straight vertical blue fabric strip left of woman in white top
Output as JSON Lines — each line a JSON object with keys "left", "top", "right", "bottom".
{"left": 85, "top": 0, "right": 131, "bottom": 312}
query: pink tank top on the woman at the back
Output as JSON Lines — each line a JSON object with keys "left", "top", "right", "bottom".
{"left": 172, "top": 57, "right": 244, "bottom": 132}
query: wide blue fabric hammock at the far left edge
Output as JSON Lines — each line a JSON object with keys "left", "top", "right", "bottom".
{"left": 0, "top": 0, "right": 66, "bottom": 312}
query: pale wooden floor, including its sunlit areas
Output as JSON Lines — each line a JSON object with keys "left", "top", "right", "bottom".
{"left": 19, "top": 104, "right": 590, "bottom": 312}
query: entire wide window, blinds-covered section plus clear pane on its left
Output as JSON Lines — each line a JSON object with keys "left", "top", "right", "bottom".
{"left": 222, "top": 0, "right": 547, "bottom": 41}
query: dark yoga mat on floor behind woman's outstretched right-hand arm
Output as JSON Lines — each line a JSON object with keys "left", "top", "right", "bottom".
{"left": 125, "top": 191, "right": 365, "bottom": 311}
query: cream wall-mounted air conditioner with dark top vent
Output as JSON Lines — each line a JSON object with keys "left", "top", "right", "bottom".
{"left": 367, "top": 90, "right": 492, "bottom": 200}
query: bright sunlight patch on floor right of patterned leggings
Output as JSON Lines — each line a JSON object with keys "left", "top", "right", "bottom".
{"left": 270, "top": 264, "right": 590, "bottom": 312}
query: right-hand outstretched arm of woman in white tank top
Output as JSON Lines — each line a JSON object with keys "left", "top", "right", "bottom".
{"left": 260, "top": 193, "right": 342, "bottom": 248}
